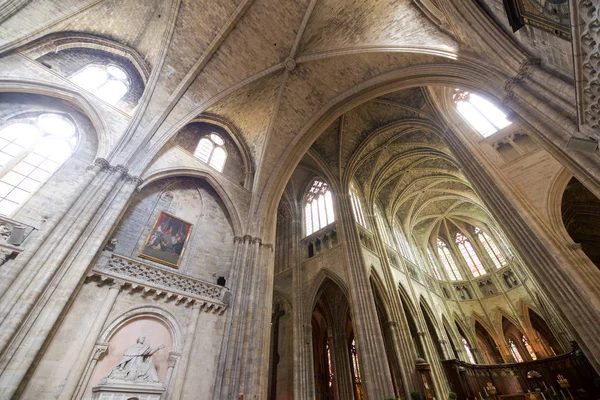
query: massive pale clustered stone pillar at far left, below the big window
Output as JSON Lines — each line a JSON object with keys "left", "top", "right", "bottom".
{"left": 0, "top": 166, "right": 139, "bottom": 398}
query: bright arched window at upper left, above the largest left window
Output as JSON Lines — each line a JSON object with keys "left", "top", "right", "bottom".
{"left": 71, "top": 64, "right": 130, "bottom": 105}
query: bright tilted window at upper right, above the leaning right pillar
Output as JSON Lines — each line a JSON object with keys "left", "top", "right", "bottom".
{"left": 454, "top": 89, "right": 511, "bottom": 137}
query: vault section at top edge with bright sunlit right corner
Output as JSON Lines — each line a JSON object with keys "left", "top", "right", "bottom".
{"left": 300, "top": 0, "right": 456, "bottom": 55}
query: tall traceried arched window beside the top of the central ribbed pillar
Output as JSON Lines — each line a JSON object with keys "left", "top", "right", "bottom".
{"left": 304, "top": 180, "right": 335, "bottom": 236}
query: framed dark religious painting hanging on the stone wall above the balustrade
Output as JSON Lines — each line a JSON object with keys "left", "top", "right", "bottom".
{"left": 139, "top": 211, "right": 192, "bottom": 268}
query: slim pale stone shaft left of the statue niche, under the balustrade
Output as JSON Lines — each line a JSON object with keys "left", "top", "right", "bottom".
{"left": 59, "top": 283, "right": 122, "bottom": 399}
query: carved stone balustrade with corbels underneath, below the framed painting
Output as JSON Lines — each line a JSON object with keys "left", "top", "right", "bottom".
{"left": 88, "top": 252, "right": 229, "bottom": 315}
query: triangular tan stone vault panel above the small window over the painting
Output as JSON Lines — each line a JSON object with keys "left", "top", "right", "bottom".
{"left": 206, "top": 72, "right": 282, "bottom": 164}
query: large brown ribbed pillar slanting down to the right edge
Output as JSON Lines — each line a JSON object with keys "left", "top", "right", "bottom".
{"left": 445, "top": 131, "right": 600, "bottom": 370}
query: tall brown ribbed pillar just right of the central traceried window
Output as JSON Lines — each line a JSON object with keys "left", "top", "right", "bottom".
{"left": 336, "top": 193, "right": 394, "bottom": 399}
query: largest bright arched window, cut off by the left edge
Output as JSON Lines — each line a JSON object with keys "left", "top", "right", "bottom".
{"left": 0, "top": 114, "right": 77, "bottom": 216}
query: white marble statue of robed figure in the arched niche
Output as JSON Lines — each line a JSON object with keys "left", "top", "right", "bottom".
{"left": 100, "top": 336, "right": 165, "bottom": 384}
